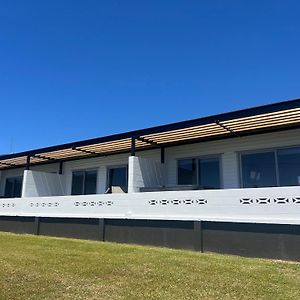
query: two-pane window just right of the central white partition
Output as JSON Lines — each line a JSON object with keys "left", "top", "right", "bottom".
{"left": 177, "top": 157, "right": 221, "bottom": 189}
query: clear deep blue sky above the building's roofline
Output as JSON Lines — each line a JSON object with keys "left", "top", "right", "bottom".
{"left": 0, "top": 0, "right": 300, "bottom": 153}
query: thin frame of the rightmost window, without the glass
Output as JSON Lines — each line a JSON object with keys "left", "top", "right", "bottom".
{"left": 238, "top": 144, "right": 300, "bottom": 189}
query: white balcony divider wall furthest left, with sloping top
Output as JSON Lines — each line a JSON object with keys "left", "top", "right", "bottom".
{"left": 22, "top": 170, "right": 66, "bottom": 197}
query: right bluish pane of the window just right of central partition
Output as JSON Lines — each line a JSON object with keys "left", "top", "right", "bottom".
{"left": 198, "top": 158, "right": 220, "bottom": 189}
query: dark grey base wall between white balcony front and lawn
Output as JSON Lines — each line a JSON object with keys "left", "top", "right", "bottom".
{"left": 0, "top": 216, "right": 300, "bottom": 261}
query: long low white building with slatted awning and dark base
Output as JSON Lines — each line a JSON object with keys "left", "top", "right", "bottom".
{"left": 0, "top": 99, "right": 300, "bottom": 260}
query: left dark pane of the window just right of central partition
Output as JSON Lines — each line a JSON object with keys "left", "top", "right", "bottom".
{"left": 178, "top": 159, "right": 197, "bottom": 184}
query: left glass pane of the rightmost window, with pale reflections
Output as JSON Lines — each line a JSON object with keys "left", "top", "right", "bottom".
{"left": 241, "top": 152, "right": 277, "bottom": 188}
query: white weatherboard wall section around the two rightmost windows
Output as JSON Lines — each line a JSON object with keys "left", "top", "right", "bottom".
{"left": 165, "top": 129, "right": 300, "bottom": 189}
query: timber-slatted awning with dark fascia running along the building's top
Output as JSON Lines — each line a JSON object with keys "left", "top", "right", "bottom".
{"left": 0, "top": 99, "right": 300, "bottom": 170}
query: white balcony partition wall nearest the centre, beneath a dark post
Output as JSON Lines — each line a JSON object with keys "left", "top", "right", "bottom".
{"left": 128, "top": 156, "right": 165, "bottom": 193}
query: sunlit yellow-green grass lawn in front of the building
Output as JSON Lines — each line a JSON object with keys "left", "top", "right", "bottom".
{"left": 0, "top": 233, "right": 300, "bottom": 300}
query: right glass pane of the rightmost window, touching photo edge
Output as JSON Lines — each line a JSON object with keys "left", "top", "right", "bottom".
{"left": 277, "top": 148, "right": 300, "bottom": 186}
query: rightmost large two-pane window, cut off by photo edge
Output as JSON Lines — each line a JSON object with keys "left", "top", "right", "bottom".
{"left": 241, "top": 147, "right": 300, "bottom": 188}
